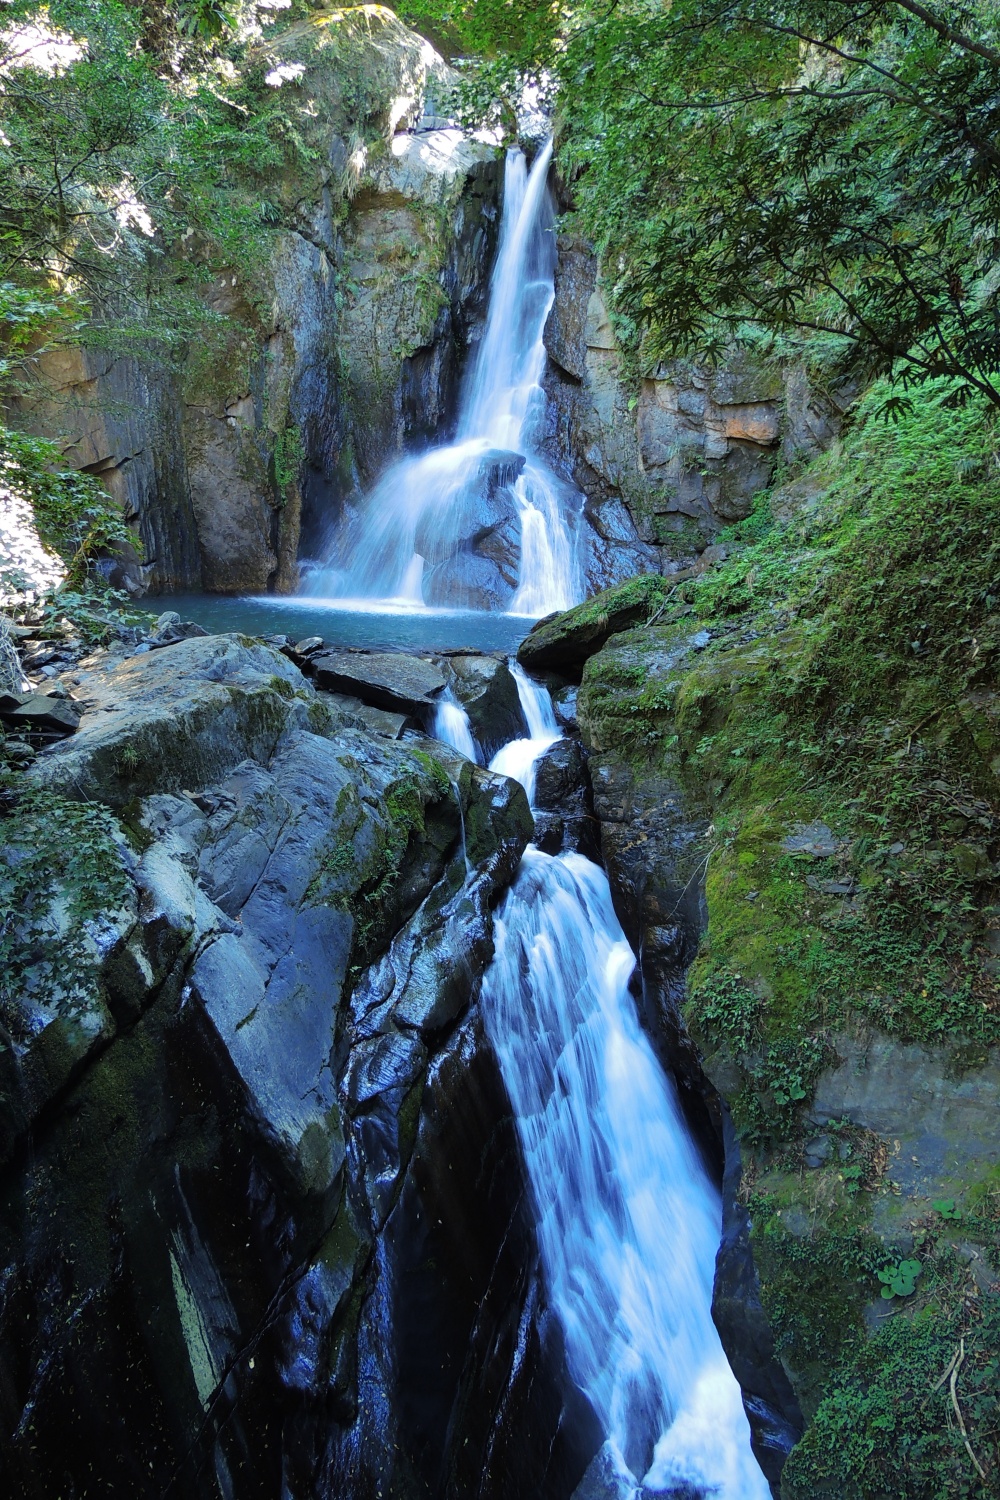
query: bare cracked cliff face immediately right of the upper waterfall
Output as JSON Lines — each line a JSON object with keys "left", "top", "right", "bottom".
{"left": 546, "top": 236, "right": 850, "bottom": 564}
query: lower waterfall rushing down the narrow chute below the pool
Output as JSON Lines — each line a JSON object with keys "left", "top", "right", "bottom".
{"left": 481, "top": 678, "right": 769, "bottom": 1500}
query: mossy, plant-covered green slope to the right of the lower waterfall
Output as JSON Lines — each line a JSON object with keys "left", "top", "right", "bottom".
{"left": 580, "top": 383, "right": 1000, "bottom": 1500}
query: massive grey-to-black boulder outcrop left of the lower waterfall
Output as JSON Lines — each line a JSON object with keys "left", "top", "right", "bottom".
{"left": 0, "top": 636, "right": 611, "bottom": 1500}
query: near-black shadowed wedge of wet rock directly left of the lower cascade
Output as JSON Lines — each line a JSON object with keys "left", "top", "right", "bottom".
{"left": 322, "top": 1011, "right": 600, "bottom": 1500}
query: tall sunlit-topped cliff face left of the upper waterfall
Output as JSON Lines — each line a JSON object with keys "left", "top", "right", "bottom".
{"left": 10, "top": 8, "right": 502, "bottom": 593}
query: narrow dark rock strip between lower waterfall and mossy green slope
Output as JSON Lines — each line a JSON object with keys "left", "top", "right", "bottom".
{"left": 569, "top": 617, "right": 802, "bottom": 1496}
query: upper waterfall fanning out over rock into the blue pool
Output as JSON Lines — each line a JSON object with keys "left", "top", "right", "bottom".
{"left": 306, "top": 143, "right": 583, "bottom": 617}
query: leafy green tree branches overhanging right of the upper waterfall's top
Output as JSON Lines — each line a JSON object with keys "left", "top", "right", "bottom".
{"left": 437, "top": 0, "right": 1000, "bottom": 405}
